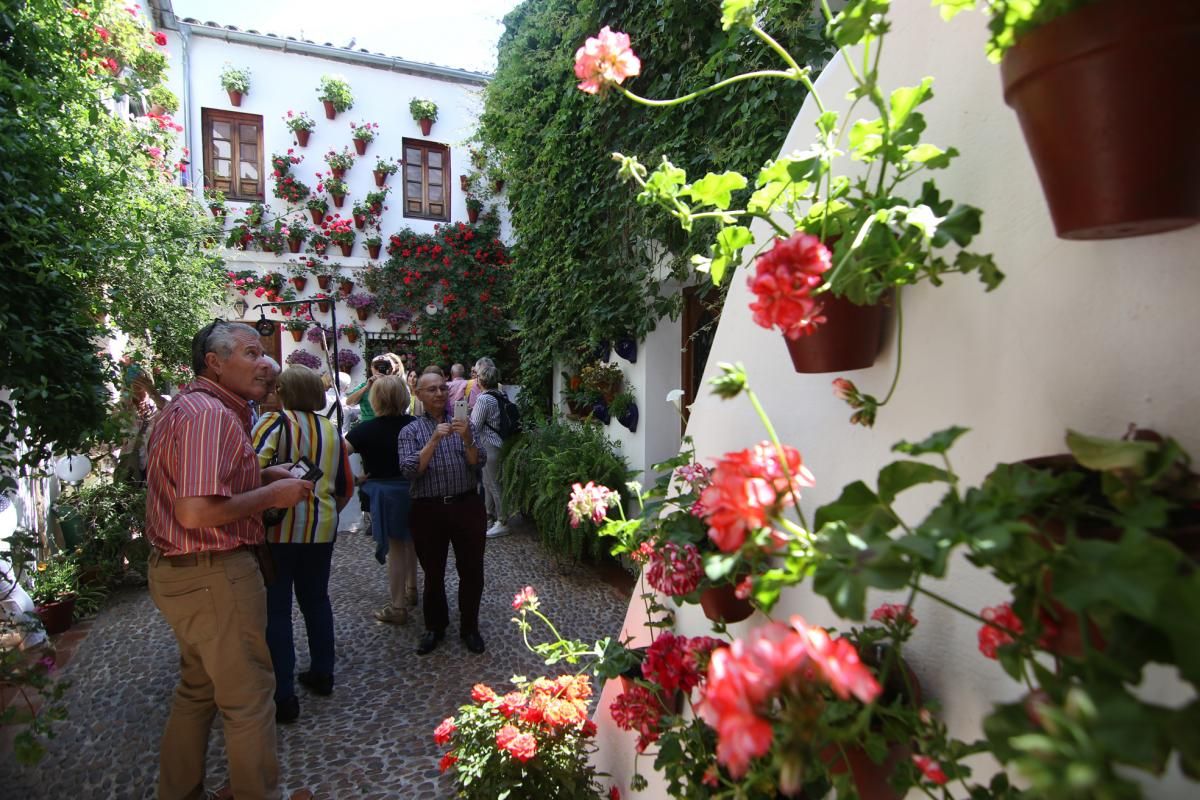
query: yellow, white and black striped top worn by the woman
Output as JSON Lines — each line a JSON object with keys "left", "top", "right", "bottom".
{"left": 251, "top": 411, "right": 353, "bottom": 545}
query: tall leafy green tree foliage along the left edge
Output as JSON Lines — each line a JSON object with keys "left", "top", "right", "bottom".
{"left": 0, "top": 0, "right": 223, "bottom": 485}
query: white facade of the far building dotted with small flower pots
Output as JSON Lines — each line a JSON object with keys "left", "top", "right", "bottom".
{"left": 156, "top": 25, "right": 509, "bottom": 379}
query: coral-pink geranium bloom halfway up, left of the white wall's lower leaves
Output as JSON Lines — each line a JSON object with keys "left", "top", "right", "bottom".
{"left": 700, "top": 441, "right": 816, "bottom": 553}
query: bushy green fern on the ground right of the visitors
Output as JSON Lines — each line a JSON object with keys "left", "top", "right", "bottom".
{"left": 500, "top": 416, "right": 632, "bottom": 559}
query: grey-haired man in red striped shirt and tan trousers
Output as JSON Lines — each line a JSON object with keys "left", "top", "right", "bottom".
{"left": 146, "top": 321, "right": 312, "bottom": 800}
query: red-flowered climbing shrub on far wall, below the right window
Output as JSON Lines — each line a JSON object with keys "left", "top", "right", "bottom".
{"left": 365, "top": 222, "right": 512, "bottom": 365}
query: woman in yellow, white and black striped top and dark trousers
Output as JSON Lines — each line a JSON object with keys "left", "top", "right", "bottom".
{"left": 252, "top": 366, "right": 354, "bottom": 722}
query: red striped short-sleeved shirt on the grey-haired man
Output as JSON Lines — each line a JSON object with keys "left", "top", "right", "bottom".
{"left": 146, "top": 378, "right": 263, "bottom": 555}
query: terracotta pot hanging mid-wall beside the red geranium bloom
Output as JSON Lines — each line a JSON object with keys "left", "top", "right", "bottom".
{"left": 784, "top": 293, "right": 887, "bottom": 374}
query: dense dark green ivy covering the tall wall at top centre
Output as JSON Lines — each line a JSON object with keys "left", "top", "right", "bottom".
{"left": 476, "top": 0, "right": 827, "bottom": 405}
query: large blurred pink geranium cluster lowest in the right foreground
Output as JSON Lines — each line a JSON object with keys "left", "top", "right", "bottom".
{"left": 697, "top": 616, "right": 881, "bottom": 778}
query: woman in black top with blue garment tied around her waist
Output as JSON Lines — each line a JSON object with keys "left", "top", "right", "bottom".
{"left": 347, "top": 375, "right": 416, "bottom": 625}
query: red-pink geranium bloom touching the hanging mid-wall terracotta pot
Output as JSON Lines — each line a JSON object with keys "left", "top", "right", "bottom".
{"left": 749, "top": 233, "right": 832, "bottom": 339}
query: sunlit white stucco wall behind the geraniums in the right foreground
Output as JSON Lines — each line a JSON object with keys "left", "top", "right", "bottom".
{"left": 598, "top": 4, "right": 1200, "bottom": 799}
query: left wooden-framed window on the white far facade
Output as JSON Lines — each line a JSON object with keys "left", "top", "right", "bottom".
{"left": 200, "top": 108, "right": 264, "bottom": 201}
